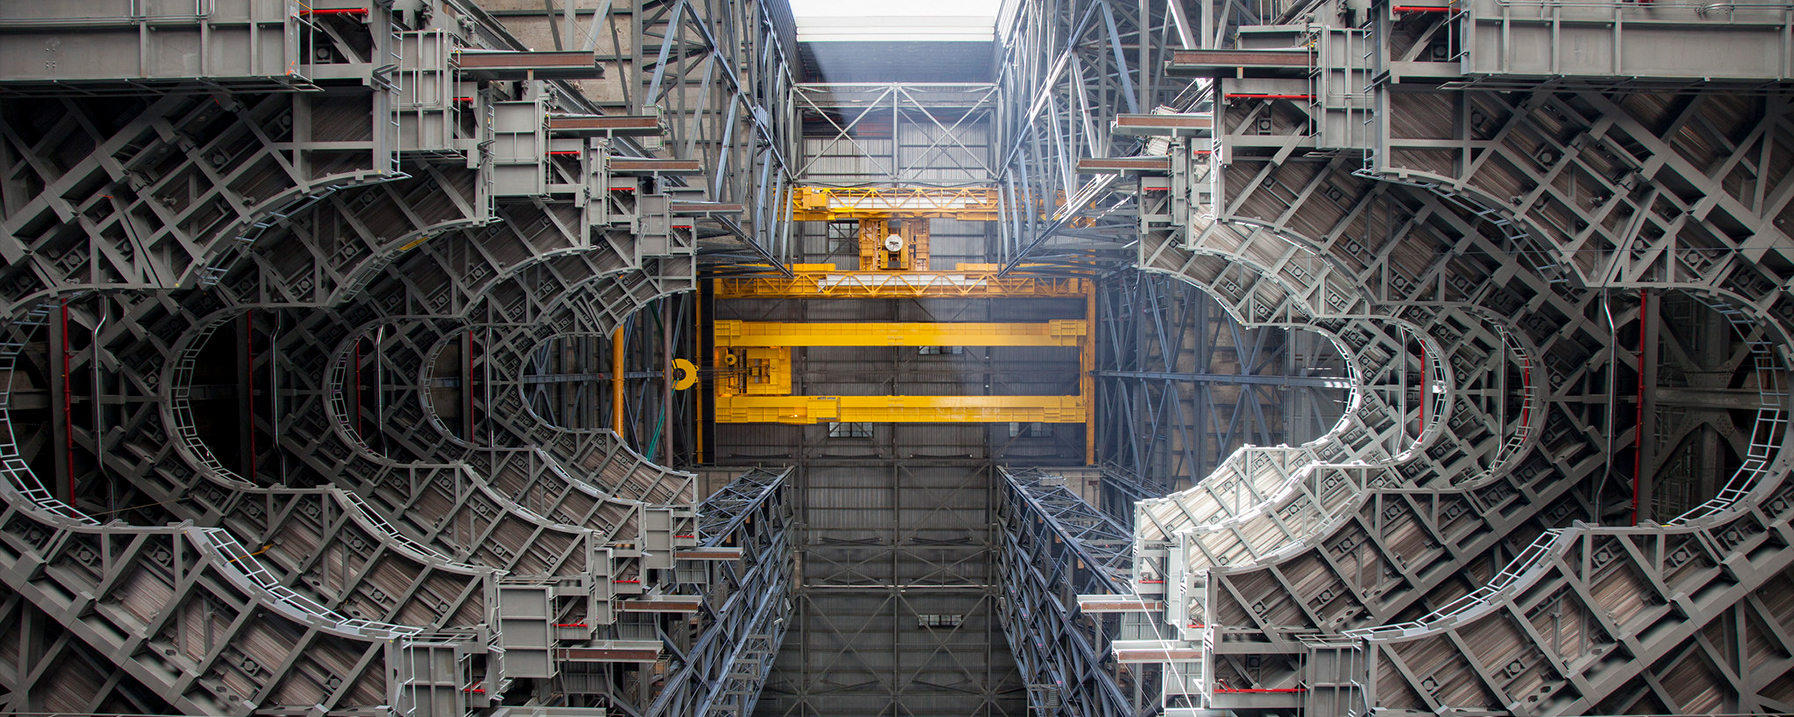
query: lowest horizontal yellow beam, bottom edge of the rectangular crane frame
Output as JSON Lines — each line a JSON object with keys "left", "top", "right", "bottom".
{"left": 716, "top": 396, "right": 1089, "bottom": 423}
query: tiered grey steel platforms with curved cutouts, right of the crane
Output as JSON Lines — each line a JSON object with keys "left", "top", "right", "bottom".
{"left": 1047, "top": 2, "right": 1794, "bottom": 713}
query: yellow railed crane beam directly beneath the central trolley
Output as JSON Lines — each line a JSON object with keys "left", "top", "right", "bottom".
{"left": 714, "top": 263, "right": 1091, "bottom": 299}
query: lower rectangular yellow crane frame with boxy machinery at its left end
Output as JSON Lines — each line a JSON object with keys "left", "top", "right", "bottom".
{"left": 716, "top": 319, "right": 1091, "bottom": 423}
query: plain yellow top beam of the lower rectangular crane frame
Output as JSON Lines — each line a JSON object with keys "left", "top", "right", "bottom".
{"left": 716, "top": 319, "right": 1089, "bottom": 348}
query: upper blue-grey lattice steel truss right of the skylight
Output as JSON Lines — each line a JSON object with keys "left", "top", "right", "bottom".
{"left": 994, "top": 0, "right": 1212, "bottom": 271}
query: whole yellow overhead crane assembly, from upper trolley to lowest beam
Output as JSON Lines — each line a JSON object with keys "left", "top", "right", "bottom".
{"left": 712, "top": 186, "right": 1096, "bottom": 462}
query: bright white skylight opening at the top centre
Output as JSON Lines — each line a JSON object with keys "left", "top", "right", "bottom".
{"left": 791, "top": 0, "right": 1003, "bottom": 43}
